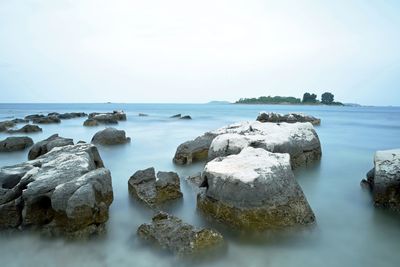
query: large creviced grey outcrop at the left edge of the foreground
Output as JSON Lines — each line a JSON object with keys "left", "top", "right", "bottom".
{"left": 0, "top": 144, "right": 113, "bottom": 237}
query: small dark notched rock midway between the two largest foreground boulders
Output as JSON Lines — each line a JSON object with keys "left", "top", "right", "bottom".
{"left": 128, "top": 168, "right": 182, "bottom": 207}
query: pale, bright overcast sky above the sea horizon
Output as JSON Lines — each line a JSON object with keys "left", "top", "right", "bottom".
{"left": 0, "top": 0, "right": 400, "bottom": 105}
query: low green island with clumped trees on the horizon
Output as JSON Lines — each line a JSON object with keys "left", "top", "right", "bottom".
{"left": 235, "top": 92, "right": 344, "bottom": 106}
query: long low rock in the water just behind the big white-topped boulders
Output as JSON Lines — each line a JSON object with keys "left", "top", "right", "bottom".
{"left": 257, "top": 111, "right": 321, "bottom": 125}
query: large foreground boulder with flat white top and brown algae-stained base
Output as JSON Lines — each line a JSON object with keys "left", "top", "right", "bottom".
{"left": 197, "top": 147, "right": 315, "bottom": 230}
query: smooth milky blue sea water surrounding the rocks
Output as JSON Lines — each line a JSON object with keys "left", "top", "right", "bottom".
{"left": 0, "top": 104, "right": 400, "bottom": 267}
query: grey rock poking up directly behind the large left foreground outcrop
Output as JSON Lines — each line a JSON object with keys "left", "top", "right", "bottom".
{"left": 28, "top": 134, "right": 74, "bottom": 160}
